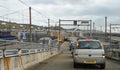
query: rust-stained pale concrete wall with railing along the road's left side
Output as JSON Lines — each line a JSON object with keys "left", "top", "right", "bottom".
{"left": 0, "top": 48, "right": 59, "bottom": 70}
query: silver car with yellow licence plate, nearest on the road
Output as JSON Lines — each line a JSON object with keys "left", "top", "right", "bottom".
{"left": 73, "top": 39, "right": 105, "bottom": 69}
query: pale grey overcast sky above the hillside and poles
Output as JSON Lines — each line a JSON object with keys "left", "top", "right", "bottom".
{"left": 0, "top": 0, "right": 120, "bottom": 25}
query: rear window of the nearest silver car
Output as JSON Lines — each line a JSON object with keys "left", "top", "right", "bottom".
{"left": 77, "top": 41, "right": 102, "bottom": 49}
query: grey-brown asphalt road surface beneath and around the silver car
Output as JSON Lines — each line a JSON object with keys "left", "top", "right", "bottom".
{"left": 29, "top": 49, "right": 120, "bottom": 70}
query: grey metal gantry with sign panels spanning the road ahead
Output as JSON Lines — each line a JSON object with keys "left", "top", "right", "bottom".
{"left": 59, "top": 20, "right": 92, "bottom": 37}
